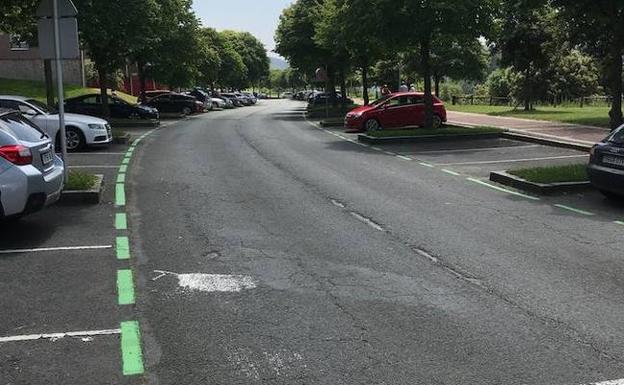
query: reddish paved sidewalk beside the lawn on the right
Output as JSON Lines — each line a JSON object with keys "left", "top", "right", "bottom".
{"left": 448, "top": 111, "right": 609, "bottom": 151}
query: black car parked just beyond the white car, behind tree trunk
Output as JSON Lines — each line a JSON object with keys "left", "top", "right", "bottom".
{"left": 65, "top": 93, "right": 160, "bottom": 120}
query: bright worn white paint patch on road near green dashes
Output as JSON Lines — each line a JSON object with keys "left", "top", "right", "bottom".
{"left": 154, "top": 270, "right": 256, "bottom": 293}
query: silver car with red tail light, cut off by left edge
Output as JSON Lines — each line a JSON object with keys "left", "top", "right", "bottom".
{"left": 0, "top": 110, "right": 64, "bottom": 219}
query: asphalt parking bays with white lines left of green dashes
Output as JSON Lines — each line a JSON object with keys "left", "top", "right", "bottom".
{"left": 0, "top": 121, "right": 163, "bottom": 384}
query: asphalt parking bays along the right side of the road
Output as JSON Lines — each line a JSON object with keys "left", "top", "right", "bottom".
{"left": 316, "top": 127, "right": 624, "bottom": 224}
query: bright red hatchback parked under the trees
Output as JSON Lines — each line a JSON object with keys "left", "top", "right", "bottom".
{"left": 345, "top": 92, "right": 446, "bottom": 132}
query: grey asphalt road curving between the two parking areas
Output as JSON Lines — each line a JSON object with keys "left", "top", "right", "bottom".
{"left": 126, "top": 101, "right": 624, "bottom": 385}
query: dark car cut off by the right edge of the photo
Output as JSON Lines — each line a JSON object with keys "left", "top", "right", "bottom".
{"left": 587, "top": 125, "right": 624, "bottom": 198}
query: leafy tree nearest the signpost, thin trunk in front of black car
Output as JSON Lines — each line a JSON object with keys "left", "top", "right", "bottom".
{"left": 74, "top": 0, "right": 147, "bottom": 116}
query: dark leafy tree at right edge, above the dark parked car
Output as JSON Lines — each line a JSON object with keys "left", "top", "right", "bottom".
{"left": 553, "top": 0, "right": 624, "bottom": 129}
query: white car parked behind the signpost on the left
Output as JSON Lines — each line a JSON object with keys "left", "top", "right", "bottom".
{"left": 0, "top": 95, "right": 113, "bottom": 151}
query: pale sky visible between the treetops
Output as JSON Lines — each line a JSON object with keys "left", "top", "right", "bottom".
{"left": 193, "top": 0, "right": 294, "bottom": 57}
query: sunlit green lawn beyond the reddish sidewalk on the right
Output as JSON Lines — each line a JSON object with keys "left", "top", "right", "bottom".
{"left": 446, "top": 104, "right": 609, "bottom": 127}
